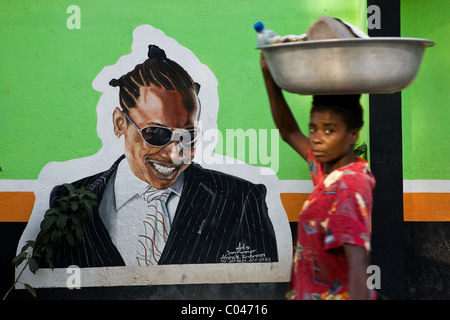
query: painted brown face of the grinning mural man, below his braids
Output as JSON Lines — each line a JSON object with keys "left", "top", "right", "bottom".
{"left": 114, "top": 86, "right": 200, "bottom": 190}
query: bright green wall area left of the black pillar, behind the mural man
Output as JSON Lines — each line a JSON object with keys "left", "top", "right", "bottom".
{"left": 0, "top": 0, "right": 366, "bottom": 180}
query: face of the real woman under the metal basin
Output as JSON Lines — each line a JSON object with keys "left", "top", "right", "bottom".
{"left": 309, "top": 111, "right": 359, "bottom": 173}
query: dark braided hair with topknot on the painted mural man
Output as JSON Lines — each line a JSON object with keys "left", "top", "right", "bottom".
{"left": 109, "top": 45, "right": 200, "bottom": 112}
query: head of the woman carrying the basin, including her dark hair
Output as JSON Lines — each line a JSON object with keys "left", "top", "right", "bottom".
{"left": 309, "top": 95, "right": 364, "bottom": 170}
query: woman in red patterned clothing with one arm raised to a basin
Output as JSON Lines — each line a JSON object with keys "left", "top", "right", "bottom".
{"left": 260, "top": 55, "right": 375, "bottom": 300}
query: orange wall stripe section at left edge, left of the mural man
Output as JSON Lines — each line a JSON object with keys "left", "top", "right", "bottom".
{"left": 0, "top": 192, "right": 35, "bottom": 222}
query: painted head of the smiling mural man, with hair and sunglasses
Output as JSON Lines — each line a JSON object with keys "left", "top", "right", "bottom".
{"left": 110, "top": 45, "right": 200, "bottom": 189}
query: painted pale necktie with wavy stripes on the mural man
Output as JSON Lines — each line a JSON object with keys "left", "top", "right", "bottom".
{"left": 136, "top": 187, "right": 170, "bottom": 266}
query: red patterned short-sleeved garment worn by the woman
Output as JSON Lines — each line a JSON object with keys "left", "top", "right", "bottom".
{"left": 286, "top": 149, "right": 375, "bottom": 300}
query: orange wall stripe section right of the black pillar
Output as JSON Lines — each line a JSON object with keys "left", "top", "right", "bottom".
{"left": 403, "top": 193, "right": 450, "bottom": 221}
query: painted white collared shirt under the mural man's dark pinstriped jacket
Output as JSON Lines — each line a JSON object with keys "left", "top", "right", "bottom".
{"left": 99, "top": 158, "right": 184, "bottom": 266}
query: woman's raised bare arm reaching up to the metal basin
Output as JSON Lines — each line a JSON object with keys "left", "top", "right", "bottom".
{"left": 260, "top": 54, "right": 310, "bottom": 160}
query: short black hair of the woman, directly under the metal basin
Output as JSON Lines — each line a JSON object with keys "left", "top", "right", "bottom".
{"left": 311, "top": 94, "right": 364, "bottom": 130}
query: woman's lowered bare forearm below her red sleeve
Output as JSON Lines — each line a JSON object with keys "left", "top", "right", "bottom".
{"left": 344, "top": 243, "right": 369, "bottom": 300}
